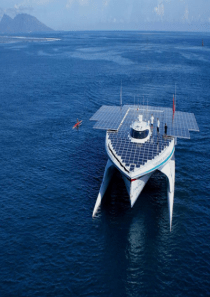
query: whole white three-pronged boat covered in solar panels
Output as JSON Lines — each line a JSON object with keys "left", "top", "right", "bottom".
{"left": 90, "top": 105, "right": 199, "bottom": 230}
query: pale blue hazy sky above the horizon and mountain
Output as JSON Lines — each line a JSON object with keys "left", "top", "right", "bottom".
{"left": 0, "top": 0, "right": 210, "bottom": 31}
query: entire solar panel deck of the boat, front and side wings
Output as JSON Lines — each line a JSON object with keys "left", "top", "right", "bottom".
{"left": 91, "top": 105, "right": 199, "bottom": 172}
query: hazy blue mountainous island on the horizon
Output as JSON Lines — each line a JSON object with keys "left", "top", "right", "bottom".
{"left": 0, "top": 13, "right": 54, "bottom": 34}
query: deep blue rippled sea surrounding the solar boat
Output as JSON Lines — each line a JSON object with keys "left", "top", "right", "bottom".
{"left": 0, "top": 32, "right": 210, "bottom": 297}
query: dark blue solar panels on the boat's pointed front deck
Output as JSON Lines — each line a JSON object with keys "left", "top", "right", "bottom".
{"left": 108, "top": 131, "right": 172, "bottom": 172}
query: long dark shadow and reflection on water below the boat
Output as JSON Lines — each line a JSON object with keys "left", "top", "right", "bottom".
{"left": 96, "top": 172, "right": 170, "bottom": 296}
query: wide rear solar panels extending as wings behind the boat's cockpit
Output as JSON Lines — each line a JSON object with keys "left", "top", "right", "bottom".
{"left": 91, "top": 105, "right": 199, "bottom": 138}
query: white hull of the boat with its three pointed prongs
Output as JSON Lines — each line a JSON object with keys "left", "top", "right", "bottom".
{"left": 93, "top": 136, "right": 175, "bottom": 230}
